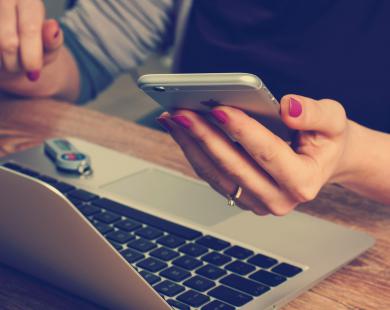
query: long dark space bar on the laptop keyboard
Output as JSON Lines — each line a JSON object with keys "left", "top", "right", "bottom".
{"left": 93, "top": 198, "right": 202, "bottom": 240}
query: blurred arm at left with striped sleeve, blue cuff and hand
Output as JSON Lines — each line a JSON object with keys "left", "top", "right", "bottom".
{"left": 0, "top": 0, "right": 174, "bottom": 102}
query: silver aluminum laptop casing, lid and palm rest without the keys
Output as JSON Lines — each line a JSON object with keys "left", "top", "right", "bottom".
{"left": 0, "top": 138, "right": 374, "bottom": 309}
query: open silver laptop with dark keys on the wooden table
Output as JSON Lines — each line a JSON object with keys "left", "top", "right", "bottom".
{"left": 0, "top": 138, "right": 374, "bottom": 310}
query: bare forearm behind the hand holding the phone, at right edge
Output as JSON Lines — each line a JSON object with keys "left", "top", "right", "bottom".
{"left": 335, "top": 121, "right": 390, "bottom": 204}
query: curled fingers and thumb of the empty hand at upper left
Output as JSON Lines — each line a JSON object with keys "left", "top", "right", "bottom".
{"left": 0, "top": 0, "right": 63, "bottom": 83}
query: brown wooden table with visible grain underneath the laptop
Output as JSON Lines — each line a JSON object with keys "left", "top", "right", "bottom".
{"left": 0, "top": 100, "right": 390, "bottom": 310}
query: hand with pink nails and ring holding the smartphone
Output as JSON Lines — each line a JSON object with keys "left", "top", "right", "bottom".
{"left": 158, "top": 95, "right": 350, "bottom": 215}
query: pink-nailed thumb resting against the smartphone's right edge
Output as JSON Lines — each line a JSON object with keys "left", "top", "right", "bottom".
{"left": 281, "top": 95, "right": 347, "bottom": 136}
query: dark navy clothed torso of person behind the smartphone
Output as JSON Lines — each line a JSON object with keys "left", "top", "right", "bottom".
{"left": 178, "top": 0, "right": 390, "bottom": 132}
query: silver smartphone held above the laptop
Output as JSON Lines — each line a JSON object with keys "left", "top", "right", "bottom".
{"left": 138, "top": 73, "right": 292, "bottom": 141}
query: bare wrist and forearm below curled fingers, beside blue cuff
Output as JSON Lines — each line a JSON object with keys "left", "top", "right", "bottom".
{"left": 0, "top": 47, "right": 80, "bottom": 101}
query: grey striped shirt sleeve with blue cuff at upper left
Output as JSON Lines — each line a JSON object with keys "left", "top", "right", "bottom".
{"left": 61, "top": 0, "right": 176, "bottom": 102}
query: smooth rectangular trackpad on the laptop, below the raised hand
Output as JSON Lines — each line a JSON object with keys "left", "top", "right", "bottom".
{"left": 102, "top": 169, "right": 240, "bottom": 226}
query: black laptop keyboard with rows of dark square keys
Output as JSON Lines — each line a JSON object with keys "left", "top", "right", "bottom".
{"left": 4, "top": 163, "right": 303, "bottom": 310}
